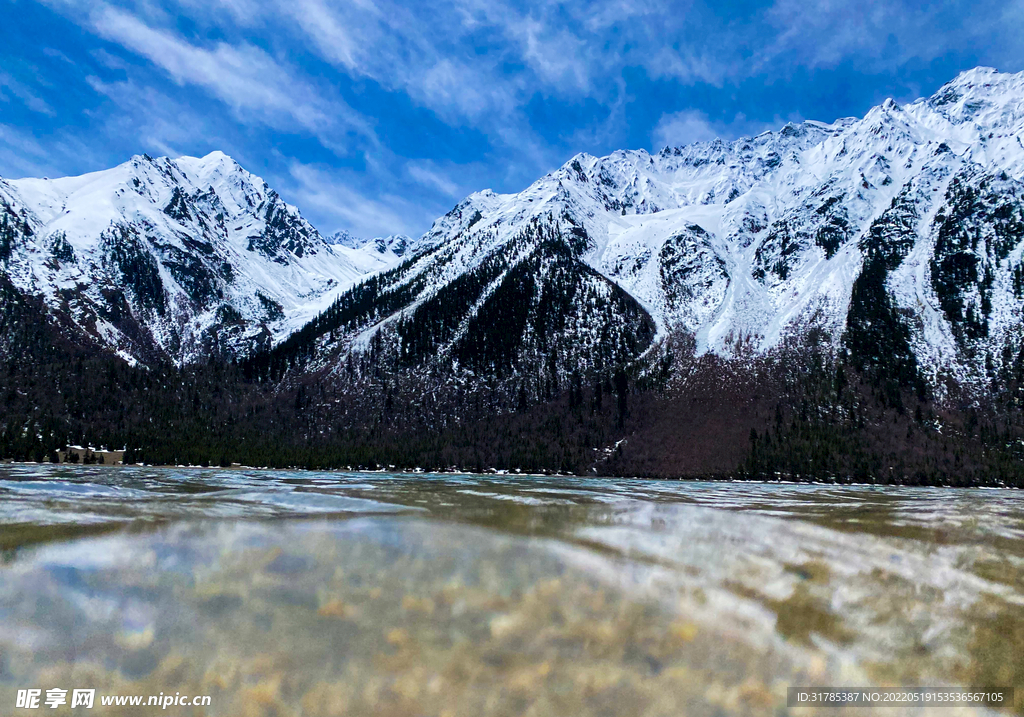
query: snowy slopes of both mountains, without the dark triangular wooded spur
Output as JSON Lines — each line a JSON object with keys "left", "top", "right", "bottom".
{"left": 8, "top": 68, "right": 1024, "bottom": 385}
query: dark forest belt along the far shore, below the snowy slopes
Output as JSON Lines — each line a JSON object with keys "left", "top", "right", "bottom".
{"left": 0, "top": 272, "right": 1024, "bottom": 487}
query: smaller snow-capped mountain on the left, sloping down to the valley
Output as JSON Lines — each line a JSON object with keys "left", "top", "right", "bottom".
{"left": 0, "top": 152, "right": 398, "bottom": 364}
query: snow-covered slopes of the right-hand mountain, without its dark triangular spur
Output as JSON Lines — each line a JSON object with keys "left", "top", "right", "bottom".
{"left": 284, "top": 68, "right": 1024, "bottom": 389}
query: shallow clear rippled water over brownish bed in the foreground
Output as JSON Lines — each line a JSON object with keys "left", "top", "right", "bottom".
{"left": 0, "top": 465, "right": 1024, "bottom": 717}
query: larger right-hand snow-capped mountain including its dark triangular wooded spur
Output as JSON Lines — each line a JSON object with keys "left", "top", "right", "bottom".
{"left": 274, "top": 68, "right": 1024, "bottom": 395}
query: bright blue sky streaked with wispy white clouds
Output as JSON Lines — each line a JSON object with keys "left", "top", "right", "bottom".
{"left": 0, "top": 0, "right": 1024, "bottom": 237}
